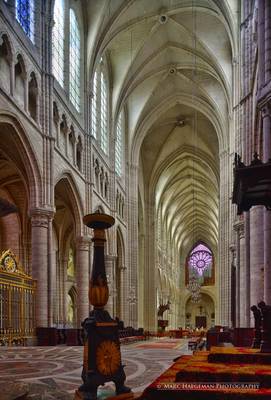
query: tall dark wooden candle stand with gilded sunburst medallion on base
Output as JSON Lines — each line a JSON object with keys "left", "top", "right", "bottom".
{"left": 75, "top": 213, "right": 133, "bottom": 400}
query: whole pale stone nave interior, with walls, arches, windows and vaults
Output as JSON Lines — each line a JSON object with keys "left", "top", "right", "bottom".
{"left": 0, "top": 0, "right": 271, "bottom": 340}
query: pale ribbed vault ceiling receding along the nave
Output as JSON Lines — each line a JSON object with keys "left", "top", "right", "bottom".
{"left": 86, "top": 0, "right": 237, "bottom": 250}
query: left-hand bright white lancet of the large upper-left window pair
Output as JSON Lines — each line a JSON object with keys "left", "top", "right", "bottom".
{"left": 52, "top": 0, "right": 64, "bottom": 86}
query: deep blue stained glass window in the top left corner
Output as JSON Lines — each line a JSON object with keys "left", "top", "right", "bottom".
{"left": 15, "top": 0, "right": 34, "bottom": 42}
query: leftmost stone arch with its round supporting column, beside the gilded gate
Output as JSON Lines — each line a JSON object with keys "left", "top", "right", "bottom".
{"left": 0, "top": 113, "right": 45, "bottom": 326}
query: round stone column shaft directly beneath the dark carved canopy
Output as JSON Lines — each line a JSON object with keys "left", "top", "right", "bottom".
{"left": 250, "top": 206, "right": 264, "bottom": 326}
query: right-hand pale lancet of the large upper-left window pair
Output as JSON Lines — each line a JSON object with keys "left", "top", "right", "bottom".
{"left": 69, "top": 9, "right": 80, "bottom": 111}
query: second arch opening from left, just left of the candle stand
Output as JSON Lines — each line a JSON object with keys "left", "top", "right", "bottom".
{"left": 53, "top": 176, "right": 88, "bottom": 325}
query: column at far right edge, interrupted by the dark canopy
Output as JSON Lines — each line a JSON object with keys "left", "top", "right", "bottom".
{"left": 262, "top": 104, "right": 271, "bottom": 304}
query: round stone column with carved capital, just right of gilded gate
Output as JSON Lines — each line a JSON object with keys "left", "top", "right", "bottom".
{"left": 30, "top": 208, "right": 50, "bottom": 327}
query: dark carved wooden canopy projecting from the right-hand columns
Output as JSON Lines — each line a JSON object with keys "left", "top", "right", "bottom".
{"left": 232, "top": 153, "right": 271, "bottom": 215}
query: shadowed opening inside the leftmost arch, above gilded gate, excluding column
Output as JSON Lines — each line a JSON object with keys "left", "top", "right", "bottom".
{"left": 0, "top": 120, "right": 42, "bottom": 275}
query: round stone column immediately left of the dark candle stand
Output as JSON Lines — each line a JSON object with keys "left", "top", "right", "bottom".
{"left": 76, "top": 236, "right": 90, "bottom": 327}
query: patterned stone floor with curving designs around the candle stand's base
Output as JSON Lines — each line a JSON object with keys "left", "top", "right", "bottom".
{"left": 0, "top": 338, "right": 190, "bottom": 400}
